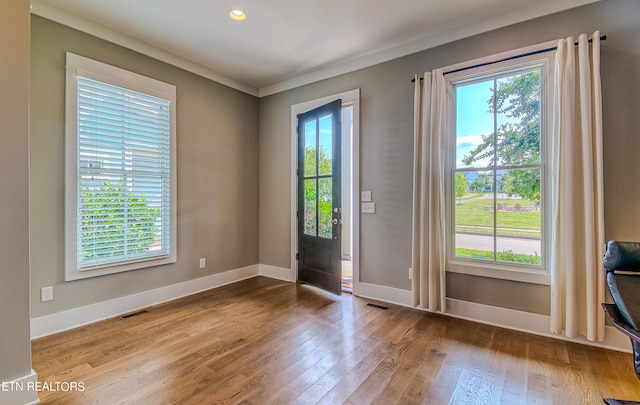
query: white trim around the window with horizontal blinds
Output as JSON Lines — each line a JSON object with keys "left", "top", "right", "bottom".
{"left": 65, "top": 52, "right": 177, "bottom": 281}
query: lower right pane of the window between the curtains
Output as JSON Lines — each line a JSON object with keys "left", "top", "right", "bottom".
{"left": 496, "top": 169, "right": 542, "bottom": 264}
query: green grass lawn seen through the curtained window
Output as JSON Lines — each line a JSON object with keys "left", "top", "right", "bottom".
{"left": 455, "top": 195, "right": 540, "bottom": 238}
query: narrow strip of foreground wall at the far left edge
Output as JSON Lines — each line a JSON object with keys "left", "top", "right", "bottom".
{"left": 0, "top": 0, "right": 31, "bottom": 382}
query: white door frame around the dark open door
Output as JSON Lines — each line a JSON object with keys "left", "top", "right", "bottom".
{"left": 290, "top": 89, "right": 360, "bottom": 295}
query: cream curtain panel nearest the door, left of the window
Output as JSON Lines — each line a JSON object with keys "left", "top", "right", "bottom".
{"left": 412, "top": 69, "right": 451, "bottom": 312}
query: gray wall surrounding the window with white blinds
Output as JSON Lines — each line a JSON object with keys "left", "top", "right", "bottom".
{"left": 30, "top": 16, "right": 258, "bottom": 318}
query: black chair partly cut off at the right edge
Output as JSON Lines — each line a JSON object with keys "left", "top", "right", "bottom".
{"left": 602, "top": 241, "right": 640, "bottom": 405}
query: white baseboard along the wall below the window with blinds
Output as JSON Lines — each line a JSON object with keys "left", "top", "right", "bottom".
{"left": 31, "top": 264, "right": 260, "bottom": 338}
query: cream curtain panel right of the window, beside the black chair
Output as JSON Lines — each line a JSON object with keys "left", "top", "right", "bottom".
{"left": 549, "top": 31, "right": 605, "bottom": 341}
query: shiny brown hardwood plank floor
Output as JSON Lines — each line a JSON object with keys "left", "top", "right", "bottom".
{"left": 33, "top": 277, "right": 640, "bottom": 405}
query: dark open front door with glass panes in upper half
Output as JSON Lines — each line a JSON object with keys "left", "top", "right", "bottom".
{"left": 297, "top": 100, "right": 342, "bottom": 295}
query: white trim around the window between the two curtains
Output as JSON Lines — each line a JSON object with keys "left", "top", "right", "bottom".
{"left": 443, "top": 41, "right": 557, "bottom": 285}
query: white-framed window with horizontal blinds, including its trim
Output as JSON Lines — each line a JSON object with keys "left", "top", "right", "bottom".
{"left": 65, "top": 54, "right": 176, "bottom": 280}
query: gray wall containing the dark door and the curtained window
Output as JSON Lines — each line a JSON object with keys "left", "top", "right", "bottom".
{"left": 260, "top": 0, "right": 640, "bottom": 314}
